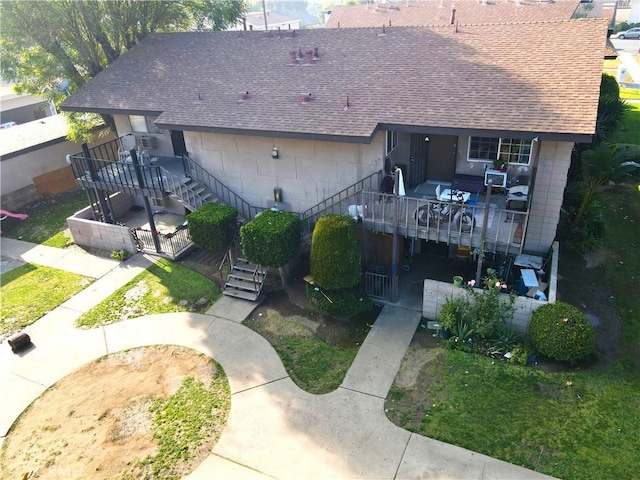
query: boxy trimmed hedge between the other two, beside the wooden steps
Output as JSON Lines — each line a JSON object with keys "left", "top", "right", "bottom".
{"left": 240, "top": 210, "right": 302, "bottom": 268}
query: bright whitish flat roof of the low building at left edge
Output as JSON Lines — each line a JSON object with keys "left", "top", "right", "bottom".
{"left": 0, "top": 115, "right": 69, "bottom": 158}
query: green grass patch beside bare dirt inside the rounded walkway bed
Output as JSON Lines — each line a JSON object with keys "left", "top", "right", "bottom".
{"left": 136, "top": 366, "right": 231, "bottom": 480}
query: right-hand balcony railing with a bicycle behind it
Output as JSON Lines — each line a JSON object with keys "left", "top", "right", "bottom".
{"left": 360, "top": 191, "right": 529, "bottom": 253}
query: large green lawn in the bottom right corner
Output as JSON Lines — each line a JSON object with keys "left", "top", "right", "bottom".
{"left": 387, "top": 350, "right": 640, "bottom": 480}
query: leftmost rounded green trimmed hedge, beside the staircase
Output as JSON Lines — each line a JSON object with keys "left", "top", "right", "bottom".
{"left": 187, "top": 203, "right": 238, "bottom": 251}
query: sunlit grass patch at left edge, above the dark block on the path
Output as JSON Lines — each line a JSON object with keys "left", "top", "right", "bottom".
{"left": 0, "top": 263, "right": 93, "bottom": 338}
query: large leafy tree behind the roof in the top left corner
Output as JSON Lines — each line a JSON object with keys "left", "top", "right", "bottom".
{"left": 0, "top": 0, "right": 245, "bottom": 141}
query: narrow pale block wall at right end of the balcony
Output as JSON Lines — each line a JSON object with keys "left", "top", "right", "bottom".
{"left": 524, "top": 142, "right": 574, "bottom": 255}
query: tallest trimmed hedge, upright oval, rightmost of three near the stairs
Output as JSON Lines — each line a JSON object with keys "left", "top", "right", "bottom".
{"left": 310, "top": 213, "right": 361, "bottom": 290}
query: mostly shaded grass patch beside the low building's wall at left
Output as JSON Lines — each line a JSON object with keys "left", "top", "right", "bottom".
{"left": 2, "top": 190, "right": 89, "bottom": 248}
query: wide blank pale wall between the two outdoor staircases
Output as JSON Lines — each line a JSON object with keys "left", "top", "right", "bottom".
{"left": 184, "top": 132, "right": 385, "bottom": 212}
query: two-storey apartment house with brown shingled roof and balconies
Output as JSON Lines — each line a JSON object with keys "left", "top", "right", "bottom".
{"left": 62, "top": 20, "right": 607, "bottom": 300}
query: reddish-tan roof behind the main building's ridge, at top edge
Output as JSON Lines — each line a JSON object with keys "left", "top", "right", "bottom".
{"left": 326, "top": 0, "right": 579, "bottom": 28}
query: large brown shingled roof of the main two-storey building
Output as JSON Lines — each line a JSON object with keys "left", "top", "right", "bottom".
{"left": 63, "top": 20, "right": 607, "bottom": 142}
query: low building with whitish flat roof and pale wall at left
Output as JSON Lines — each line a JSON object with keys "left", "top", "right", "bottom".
{"left": 0, "top": 115, "right": 114, "bottom": 210}
